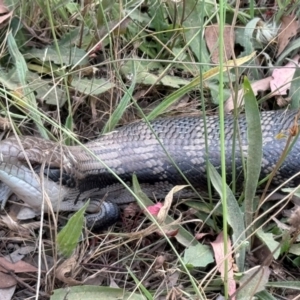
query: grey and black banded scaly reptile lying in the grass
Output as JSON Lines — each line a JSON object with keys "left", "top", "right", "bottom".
{"left": 0, "top": 110, "right": 300, "bottom": 228}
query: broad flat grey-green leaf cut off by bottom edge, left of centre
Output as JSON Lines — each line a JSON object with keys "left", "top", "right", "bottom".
{"left": 50, "top": 285, "right": 146, "bottom": 300}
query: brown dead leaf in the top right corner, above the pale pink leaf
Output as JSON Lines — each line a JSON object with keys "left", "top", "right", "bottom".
{"left": 276, "top": 16, "right": 299, "bottom": 57}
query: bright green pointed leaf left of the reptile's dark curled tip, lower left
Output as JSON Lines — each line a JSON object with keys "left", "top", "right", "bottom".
{"left": 56, "top": 201, "right": 89, "bottom": 257}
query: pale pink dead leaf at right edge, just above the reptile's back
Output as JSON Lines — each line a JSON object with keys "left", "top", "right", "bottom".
{"left": 270, "top": 55, "right": 300, "bottom": 96}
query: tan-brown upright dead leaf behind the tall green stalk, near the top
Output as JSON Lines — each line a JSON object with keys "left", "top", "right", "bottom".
{"left": 204, "top": 24, "right": 235, "bottom": 64}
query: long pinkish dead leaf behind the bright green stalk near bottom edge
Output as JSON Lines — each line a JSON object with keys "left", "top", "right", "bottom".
{"left": 210, "top": 232, "right": 236, "bottom": 300}
